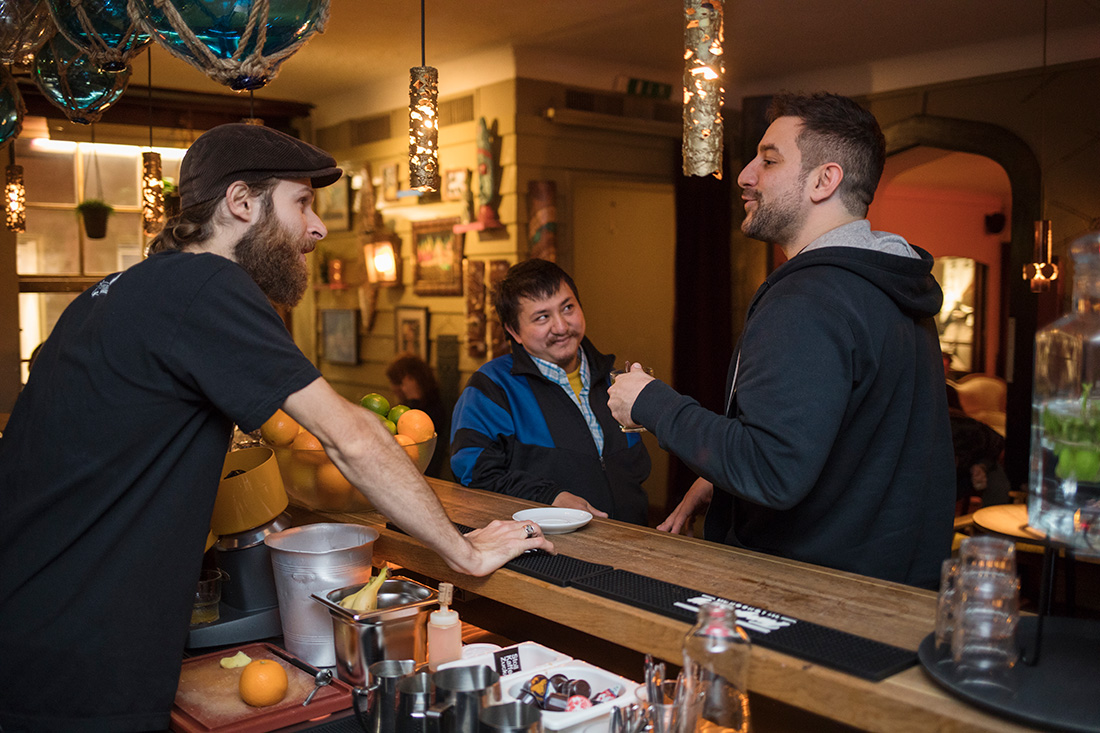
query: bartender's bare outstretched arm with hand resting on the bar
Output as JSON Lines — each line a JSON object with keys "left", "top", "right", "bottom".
{"left": 283, "top": 379, "right": 554, "bottom": 576}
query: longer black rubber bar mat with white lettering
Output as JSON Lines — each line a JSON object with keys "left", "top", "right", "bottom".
{"left": 568, "top": 570, "right": 917, "bottom": 681}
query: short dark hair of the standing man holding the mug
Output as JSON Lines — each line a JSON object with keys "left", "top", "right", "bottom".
{"left": 768, "top": 92, "right": 887, "bottom": 217}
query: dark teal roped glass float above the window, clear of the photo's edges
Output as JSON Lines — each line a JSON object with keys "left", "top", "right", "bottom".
{"left": 33, "top": 33, "right": 130, "bottom": 124}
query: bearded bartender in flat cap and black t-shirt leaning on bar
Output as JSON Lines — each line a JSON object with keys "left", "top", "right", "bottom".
{"left": 0, "top": 124, "right": 552, "bottom": 732}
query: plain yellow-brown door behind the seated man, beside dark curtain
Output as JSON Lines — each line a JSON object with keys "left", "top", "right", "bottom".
{"left": 572, "top": 178, "right": 675, "bottom": 519}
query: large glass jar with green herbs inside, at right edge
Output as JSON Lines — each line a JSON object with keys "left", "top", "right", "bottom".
{"left": 1027, "top": 232, "right": 1100, "bottom": 556}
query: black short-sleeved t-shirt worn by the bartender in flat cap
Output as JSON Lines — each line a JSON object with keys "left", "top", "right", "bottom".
{"left": 0, "top": 252, "right": 320, "bottom": 731}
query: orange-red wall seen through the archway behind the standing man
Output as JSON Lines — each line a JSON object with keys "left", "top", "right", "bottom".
{"left": 867, "top": 184, "right": 1009, "bottom": 374}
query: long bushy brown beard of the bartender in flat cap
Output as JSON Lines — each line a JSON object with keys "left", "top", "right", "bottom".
{"left": 233, "top": 207, "right": 312, "bottom": 308}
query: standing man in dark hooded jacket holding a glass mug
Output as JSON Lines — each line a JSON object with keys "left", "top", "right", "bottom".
{"left": 611, "top": 95, "right": 955, "bottom": 587}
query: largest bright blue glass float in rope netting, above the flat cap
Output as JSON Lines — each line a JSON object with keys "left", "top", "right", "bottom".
{"left": 130, "top": 0, "right": 329, "bottom": 91}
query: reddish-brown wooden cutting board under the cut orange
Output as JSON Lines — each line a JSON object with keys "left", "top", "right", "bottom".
{"left": 172, "top": 643, "right": 351, "bottom": 733}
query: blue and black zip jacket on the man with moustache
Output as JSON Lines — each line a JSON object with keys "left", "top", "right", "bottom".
{"left": 451, "top": 338, "right": 650, "bottom": 525}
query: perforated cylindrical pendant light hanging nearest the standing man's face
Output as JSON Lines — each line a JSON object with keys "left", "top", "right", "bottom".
{"left": 683, "top": 0, "right": 726, "bottom": 178}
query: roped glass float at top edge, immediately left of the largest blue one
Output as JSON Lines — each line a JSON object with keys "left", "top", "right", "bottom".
{"left": 47, "top": 0, "right": 150, "bottom": 72}
